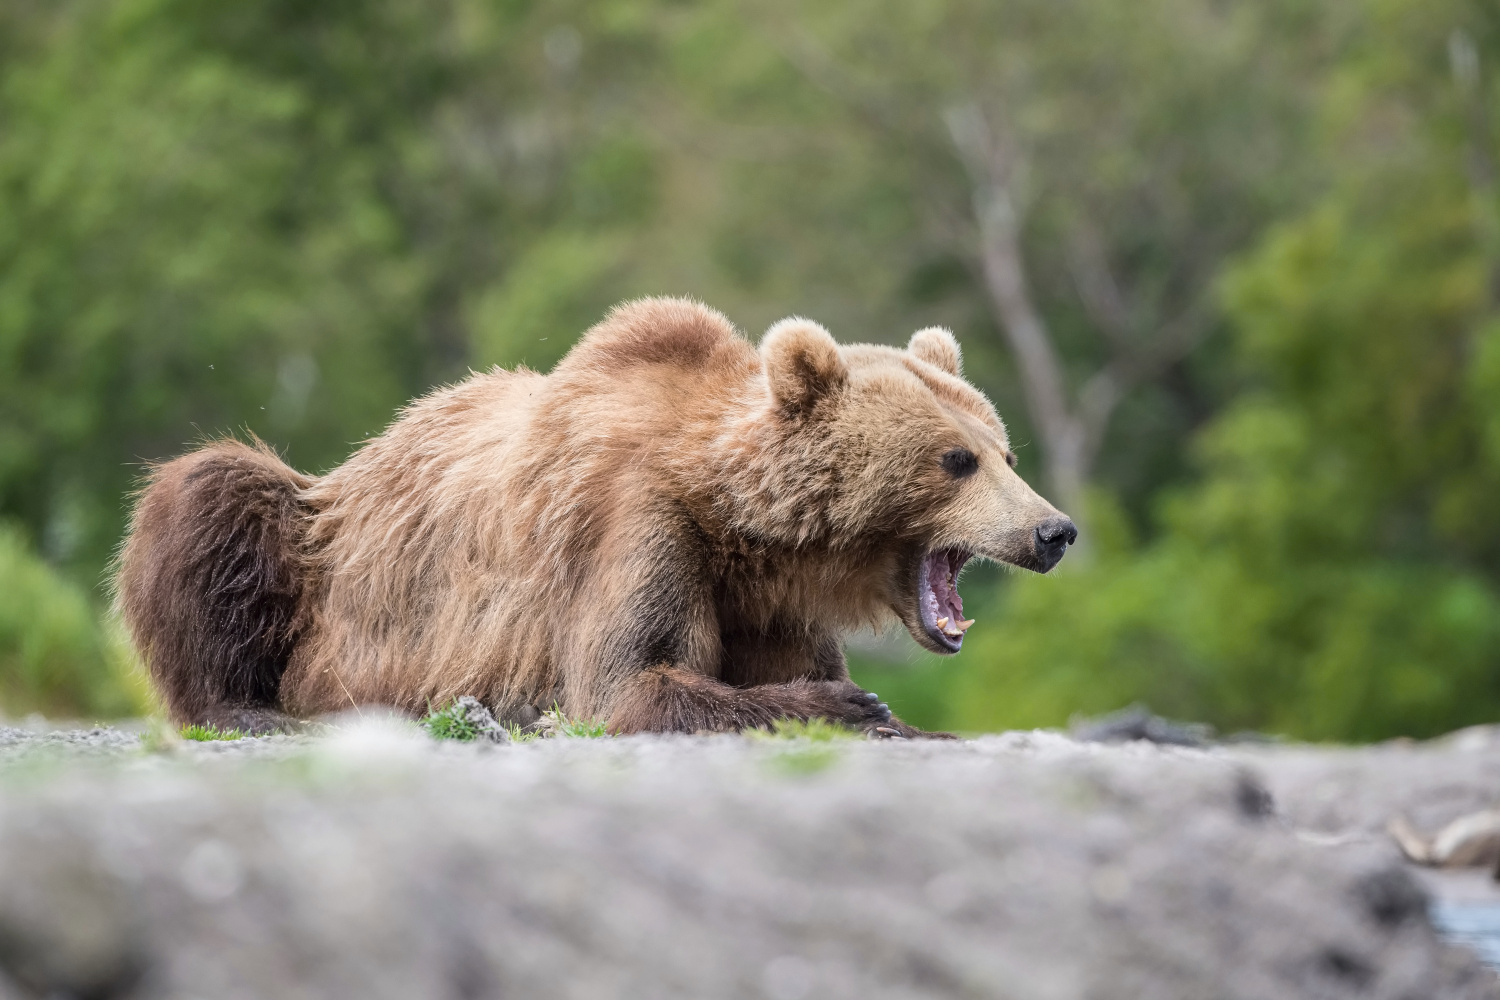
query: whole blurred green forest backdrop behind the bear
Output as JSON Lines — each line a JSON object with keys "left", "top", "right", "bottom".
{"left": 0, "top": 0, "right": 1500, "bottom": 739}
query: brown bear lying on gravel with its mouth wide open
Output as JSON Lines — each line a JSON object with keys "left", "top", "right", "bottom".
{"left": 117, "top": 298, "right": 1077, "bottom": 735}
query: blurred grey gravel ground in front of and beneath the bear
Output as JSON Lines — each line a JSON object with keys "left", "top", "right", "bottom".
{"left": 0, "top": 720, "right": 1500, "bottom": 1000}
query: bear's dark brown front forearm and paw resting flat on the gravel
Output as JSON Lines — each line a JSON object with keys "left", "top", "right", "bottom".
{"left": 609, "top": 666, "right": 923, "bottom": 736}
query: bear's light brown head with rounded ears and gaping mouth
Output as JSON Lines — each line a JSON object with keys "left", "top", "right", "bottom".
{"left": 761, "top": 318, "right": 1077, "bottom": 654}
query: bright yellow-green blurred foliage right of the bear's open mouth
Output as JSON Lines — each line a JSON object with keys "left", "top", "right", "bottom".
{"left": 953, "top": 0, "right": 1500, "bottom": 739}
